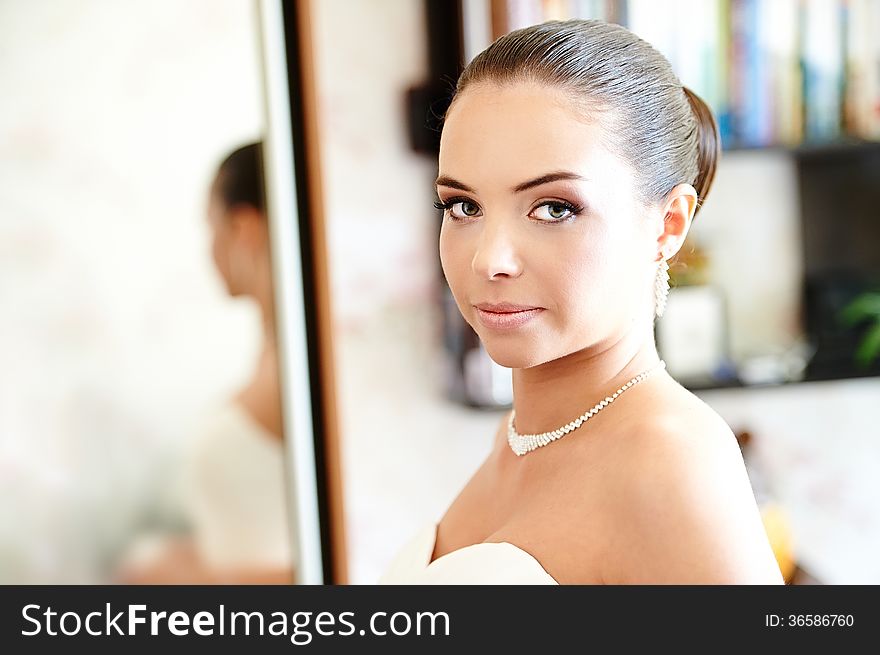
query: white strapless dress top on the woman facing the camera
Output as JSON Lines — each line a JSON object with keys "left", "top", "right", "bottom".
{"left": 379, "top": 522, "right": 559, "bottom": 585}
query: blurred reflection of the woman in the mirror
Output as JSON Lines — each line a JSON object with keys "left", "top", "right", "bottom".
{"left": 121, "top": 143, "right": 294, "bottom": 584}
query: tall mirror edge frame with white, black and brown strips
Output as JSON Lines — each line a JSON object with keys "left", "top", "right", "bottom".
{"left": 259, "top": 0, "right": 347, "bottom": 584}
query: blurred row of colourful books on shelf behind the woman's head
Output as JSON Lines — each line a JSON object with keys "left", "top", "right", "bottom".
{"left": 474, "top": 0, "right": 880, "bottom": 150}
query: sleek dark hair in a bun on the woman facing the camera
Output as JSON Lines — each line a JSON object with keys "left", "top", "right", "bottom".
{"left": 453, "top": 20, "right": 721, "bottom": 214}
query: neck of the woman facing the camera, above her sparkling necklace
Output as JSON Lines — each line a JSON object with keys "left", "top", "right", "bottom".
{"left": 513, "top": 328, "right": 659, "bottom": 434}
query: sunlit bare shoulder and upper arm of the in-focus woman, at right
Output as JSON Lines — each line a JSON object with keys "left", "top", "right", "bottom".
{"left": 603, "top": 387, "right": 782, "bottom": 584}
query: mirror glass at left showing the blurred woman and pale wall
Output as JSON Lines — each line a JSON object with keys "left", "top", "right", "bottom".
{"left": 0, "top": 0, "right": 296, "bottom": 584}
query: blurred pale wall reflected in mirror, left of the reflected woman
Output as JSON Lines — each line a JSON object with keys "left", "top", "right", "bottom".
{"left": 0, "top": 0, "right": 262, "bottom": 582}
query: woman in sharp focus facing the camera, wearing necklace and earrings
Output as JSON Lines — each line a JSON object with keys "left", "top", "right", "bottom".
{"left": 381, "top": 20, "right": 782, "bottom": 584}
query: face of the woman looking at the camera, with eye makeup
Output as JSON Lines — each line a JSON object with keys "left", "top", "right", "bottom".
{"left": 437, "top": 83, "right": 658, "bottom": 368}
